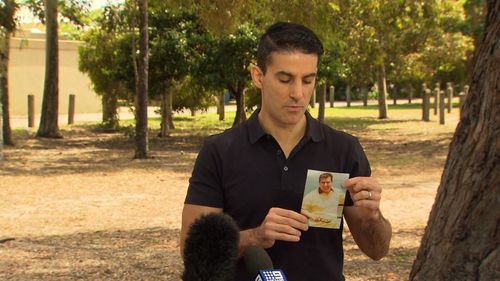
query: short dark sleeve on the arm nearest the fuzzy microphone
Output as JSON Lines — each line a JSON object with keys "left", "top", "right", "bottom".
{"left": 184, "top": 138, "right": 224, "bottom": 208}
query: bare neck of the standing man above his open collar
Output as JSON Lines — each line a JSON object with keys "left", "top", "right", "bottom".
{"left": 259, "top": 111, "right": 307, "bottom": 158}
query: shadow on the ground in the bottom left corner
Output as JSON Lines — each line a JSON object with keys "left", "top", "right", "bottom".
{"left": 0, "top": 228, "right": 183, "bottom": 280}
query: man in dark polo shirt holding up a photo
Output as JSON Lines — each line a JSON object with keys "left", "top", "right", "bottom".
{"left": 181, "top": 23, "right": 391, "bottom": 281}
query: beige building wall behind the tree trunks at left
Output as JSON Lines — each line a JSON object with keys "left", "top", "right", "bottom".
{"left": 9, "top": 30, "right": 101, "bottom": 117}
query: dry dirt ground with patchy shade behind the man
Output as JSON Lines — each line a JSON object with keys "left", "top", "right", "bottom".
{"left": 0, "top": 113, "right": 452, "bottom": 280}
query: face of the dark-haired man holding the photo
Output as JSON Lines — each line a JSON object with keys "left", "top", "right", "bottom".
{"left": 252, "top": 51, "right": 318, "bottom": 127}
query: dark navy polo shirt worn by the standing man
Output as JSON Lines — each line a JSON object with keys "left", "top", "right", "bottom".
{"left": 185, "top": 111, "right": 370, "bottom": 281}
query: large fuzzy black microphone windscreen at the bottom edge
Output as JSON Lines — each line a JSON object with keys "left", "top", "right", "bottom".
{"left": 182, "top": 213, "right": 240, "bottom": 281}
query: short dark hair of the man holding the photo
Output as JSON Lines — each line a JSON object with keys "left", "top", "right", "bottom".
{"left": 257, "top": 22, "right": 323, "bottom": 74}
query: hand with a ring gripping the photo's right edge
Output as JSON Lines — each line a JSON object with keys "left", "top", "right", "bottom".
{"left": 342, "top": 177, "right": 382, "bottom": 220}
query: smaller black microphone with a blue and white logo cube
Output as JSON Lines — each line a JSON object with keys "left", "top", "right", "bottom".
{"left": 243, "top": 246, "right": 287, "bottom": 281}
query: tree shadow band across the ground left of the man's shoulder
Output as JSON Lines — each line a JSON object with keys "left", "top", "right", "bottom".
{"left": 0, "top": 126, "right": 209, "bottom": 176}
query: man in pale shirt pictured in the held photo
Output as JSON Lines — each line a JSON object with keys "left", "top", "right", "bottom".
{"left": 301, "top": 173, "right": 345, "bottom": 229}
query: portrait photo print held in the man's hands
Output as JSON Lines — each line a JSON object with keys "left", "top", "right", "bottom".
{"left": 301, "top": 170, "right": 349, "bottom": 229}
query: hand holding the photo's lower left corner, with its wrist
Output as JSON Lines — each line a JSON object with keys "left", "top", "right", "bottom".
{"left": 241, "top": 208, "right": 308, "bottom": 248}
